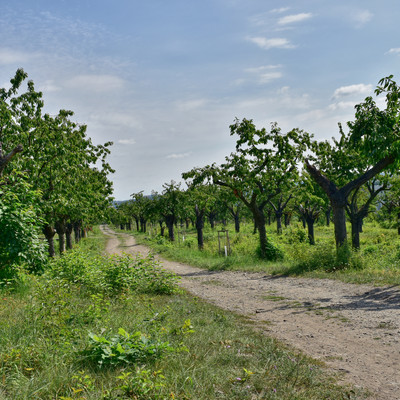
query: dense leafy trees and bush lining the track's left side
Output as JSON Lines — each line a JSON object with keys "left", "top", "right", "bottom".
{"left": 0, "top": 69, "right": 113, "bottom": 276}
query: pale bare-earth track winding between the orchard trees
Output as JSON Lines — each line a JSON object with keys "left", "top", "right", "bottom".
{"left": 102, "top": 227, "right": 400, "bottom": 400}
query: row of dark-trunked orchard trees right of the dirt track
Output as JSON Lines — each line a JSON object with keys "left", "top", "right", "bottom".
{"left": 114, "top": 76, "right": 400, "bottom": 259}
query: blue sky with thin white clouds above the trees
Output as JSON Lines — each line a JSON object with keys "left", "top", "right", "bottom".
{"left": 0, "top": 0, "right": 400, "bottom": 200}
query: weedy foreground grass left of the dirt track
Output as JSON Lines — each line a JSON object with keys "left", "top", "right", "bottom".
{"left": 0, "top": 227, "right": 363, "bottom": 400}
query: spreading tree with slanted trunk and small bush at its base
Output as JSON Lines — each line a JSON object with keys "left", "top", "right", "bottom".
{"left": 186, "top": 119, "right": 310, "bottom": 259}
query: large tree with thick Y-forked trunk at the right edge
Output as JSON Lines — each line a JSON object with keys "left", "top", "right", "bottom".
{"left": 305, "top": 76, "right": 400, "bottom": 249}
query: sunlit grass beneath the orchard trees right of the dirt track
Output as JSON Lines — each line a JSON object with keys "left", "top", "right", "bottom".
{"left": 125, "top": 217, "right": 400, "bottom": 285}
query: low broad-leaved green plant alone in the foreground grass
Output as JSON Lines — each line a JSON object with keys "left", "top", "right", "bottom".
{"left": 83, "top": 328, "right": 174, "bottom": 366}
